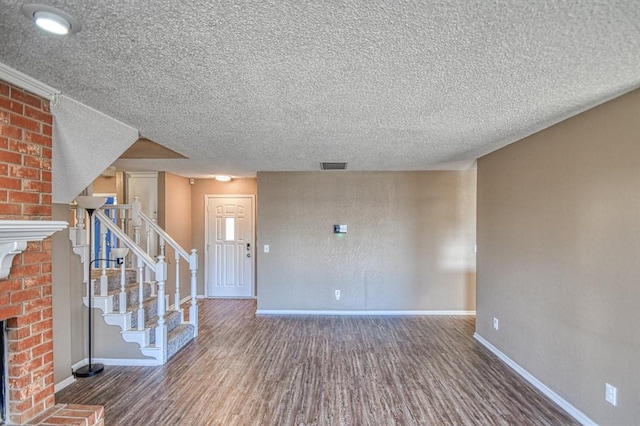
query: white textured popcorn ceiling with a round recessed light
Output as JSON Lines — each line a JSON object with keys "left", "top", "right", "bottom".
{"left": 0, "top": 0, "right": 640, "bottom": 177}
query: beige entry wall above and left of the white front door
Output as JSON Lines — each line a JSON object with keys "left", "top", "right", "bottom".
{"left": 191, "top": 178, "right": 259, "bottom": 295}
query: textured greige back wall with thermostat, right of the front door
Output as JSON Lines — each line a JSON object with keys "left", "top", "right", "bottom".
{"left": 257, "top": 171, "right": 476, "bottom": 310}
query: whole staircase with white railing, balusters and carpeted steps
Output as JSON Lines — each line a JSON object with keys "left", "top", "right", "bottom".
{"left": 69, "top": 197, "right": 198, "bottom": 365}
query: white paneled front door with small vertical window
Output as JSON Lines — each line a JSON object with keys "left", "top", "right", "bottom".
{"left": 205, "top": 195, "right": 254, "bottom": 297}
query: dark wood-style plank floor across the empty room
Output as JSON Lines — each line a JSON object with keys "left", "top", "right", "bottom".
{"left": 56, "top": 299, "right": 577, "bottom": 425}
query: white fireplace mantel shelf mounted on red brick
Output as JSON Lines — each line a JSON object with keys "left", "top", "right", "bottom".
{"left": 0, "top": 220, "right": 69, "bottom": 279}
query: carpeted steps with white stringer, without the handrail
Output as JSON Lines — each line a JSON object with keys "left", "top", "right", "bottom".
{"left": 83, "top": 269, "right": 195, "bottom": 363}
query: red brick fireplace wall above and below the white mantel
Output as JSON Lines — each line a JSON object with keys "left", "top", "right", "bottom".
{"left": 0, "top": 81, "right": 55, "bottom": 424}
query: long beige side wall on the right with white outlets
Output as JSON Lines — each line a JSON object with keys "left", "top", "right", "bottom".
{"left": 477, "top": 91, "right": 640, "bottom": 425}
